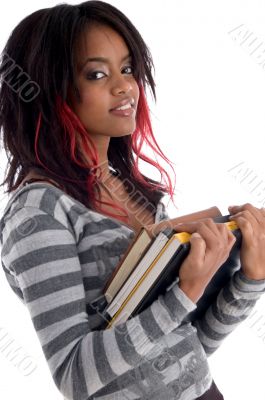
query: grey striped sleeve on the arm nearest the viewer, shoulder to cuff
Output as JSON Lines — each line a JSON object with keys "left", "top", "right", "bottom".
{"left": 1, "top": 205, "right": 196, "bottom": 400}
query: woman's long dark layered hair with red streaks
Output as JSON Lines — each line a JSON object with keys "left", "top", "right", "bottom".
{"left": 0, "top": 1, "right": 175, "bottom": 222}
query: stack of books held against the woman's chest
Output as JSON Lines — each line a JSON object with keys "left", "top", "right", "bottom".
{"left": 99, "top": 207, "right": 241, "bottom": 329}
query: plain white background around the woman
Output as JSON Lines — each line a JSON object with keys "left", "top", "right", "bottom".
{"left": 0, "top": 0, "right": 265, "bottom": 400}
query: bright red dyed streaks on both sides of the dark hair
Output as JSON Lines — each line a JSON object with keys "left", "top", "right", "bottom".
{"left": 34, "top": 86, "right": 175, "bottom": 223}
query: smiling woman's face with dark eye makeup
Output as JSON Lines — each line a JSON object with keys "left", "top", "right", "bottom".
{"left": 70, "top": 25, "right": 139, "bottom": 139}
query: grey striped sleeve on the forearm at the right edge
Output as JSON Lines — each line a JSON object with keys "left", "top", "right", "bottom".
{"left": 194, "top": 269, "right": 265, "bottom": 356}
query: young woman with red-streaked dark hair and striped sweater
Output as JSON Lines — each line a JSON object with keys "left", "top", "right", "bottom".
{"left": 0, "top": 1, "right": 265, "bottom": 400}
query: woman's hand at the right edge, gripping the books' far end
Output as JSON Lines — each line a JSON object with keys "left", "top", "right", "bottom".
{"left": 228, "top": 203, "right": 265, "bottom": 280}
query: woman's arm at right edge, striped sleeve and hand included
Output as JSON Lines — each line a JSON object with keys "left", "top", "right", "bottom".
{"left": 194, "top": 204, "right": 265, "bottom": 355}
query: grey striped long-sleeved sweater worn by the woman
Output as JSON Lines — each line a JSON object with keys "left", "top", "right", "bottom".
{"left": 0, "top": 182, "right": 265, "bottom": 400}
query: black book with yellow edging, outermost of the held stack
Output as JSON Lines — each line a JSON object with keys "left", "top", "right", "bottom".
{"left": 104, "top": 216, "right": 241, "bottom": 328}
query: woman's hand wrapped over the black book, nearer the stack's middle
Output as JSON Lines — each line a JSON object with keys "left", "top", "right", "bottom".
{"left": 174, "top": 218, "right": 236, "bottom": 303}
